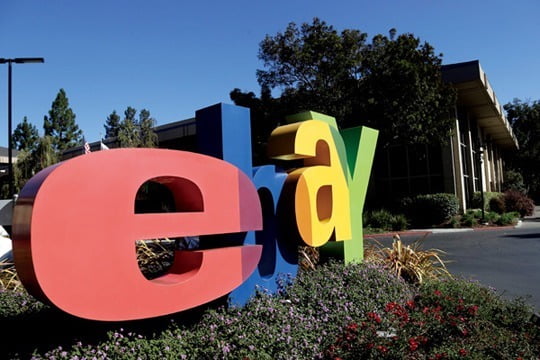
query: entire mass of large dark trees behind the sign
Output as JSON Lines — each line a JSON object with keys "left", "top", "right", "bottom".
{"left": 234, "top": 18, "right": 456, "bottom": 158}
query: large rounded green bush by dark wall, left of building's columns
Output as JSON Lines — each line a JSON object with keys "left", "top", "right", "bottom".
{"left": 403, "top": 193, "right": 459, "bottom": 226}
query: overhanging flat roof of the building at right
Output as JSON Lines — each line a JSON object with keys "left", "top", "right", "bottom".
{"left": 442, "top": 60, "right": 519, "bottom": 149}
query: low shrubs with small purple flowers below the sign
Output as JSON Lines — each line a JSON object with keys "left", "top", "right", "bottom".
{"left": 30, "top": 261, "right": 414, "bottom": 359}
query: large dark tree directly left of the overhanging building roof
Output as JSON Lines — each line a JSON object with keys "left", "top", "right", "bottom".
{"left": 354, "top": 30, "right": 456, "bottom": 144}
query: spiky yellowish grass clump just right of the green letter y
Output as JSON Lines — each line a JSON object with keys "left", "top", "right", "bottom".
{"left": 364, "top": 234, "right": 452, "bottom": 284}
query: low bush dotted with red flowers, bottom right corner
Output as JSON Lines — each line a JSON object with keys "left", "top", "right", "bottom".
{"left": 325, "top": 280, "right": 540, "bottom": 359}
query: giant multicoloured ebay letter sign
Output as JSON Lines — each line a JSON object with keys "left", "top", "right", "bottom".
{"left": 12, "top": 104, "right": 377, "bottom": 321}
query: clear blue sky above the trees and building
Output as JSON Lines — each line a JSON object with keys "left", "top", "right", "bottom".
{"left": 0, "top": 0, "right": 540, "bottom": 146}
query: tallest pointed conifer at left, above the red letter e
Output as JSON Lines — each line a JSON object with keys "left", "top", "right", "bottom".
{"left": 43, "top": 89, "right": 82, "bottom": 156}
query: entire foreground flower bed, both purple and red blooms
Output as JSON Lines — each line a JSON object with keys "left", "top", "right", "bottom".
{"left": 4, "top": 261, "right": 540, "bottom": 360}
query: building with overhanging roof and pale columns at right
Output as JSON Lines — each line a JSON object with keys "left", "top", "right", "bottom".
{"left": 371, "top": 61, "right": 518, "bottom": 210}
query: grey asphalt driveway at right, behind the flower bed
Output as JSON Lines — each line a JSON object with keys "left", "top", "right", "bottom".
{"left": 366, "top": 207, "right": 540, "bottom": 311}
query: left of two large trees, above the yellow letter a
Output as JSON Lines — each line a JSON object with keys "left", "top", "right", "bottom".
{"left": 257, "top": 18, "right": 367, "bottom": 125}
